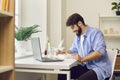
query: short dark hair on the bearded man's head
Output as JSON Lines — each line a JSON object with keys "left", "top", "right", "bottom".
{"left": 66, "top": 13, "right": 85, "bottom": 26}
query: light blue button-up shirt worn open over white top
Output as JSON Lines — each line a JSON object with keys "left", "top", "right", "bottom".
{"left": 70, "top": 26, "right": 112, "bottom": 80}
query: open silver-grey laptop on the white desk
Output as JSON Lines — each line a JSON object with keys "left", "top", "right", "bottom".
{"left": 31, "top": 37, "right": 63, "bottom": 62}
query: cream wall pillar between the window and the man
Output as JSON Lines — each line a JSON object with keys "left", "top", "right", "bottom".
{"left": 47, "top": 0, "right": 66, "bottom": 47}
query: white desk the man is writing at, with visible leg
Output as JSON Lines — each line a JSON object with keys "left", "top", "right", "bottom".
{"left": 15, "top": 57, "right": 77, "bottom": 80}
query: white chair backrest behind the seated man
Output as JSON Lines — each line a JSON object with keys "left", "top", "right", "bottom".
{"left": 107, "top": 49, "right": 117, "bottom": 80}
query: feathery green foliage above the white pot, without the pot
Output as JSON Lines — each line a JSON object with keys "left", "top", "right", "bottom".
{"left": 15, "top": 25, "right": 39, "bottom": 41}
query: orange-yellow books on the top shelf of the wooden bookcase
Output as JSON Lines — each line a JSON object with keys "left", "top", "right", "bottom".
{"left": 0, "top": 0, "right": 10, "bottom": 12}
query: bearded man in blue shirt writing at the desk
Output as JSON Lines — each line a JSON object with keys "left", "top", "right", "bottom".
{"left": 58, "top": 13, "right": 112, "bottom": 80}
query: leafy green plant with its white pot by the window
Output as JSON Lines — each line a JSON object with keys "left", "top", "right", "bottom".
{"left": 15, "top": 25, "right": 40, "bottom": 54}
